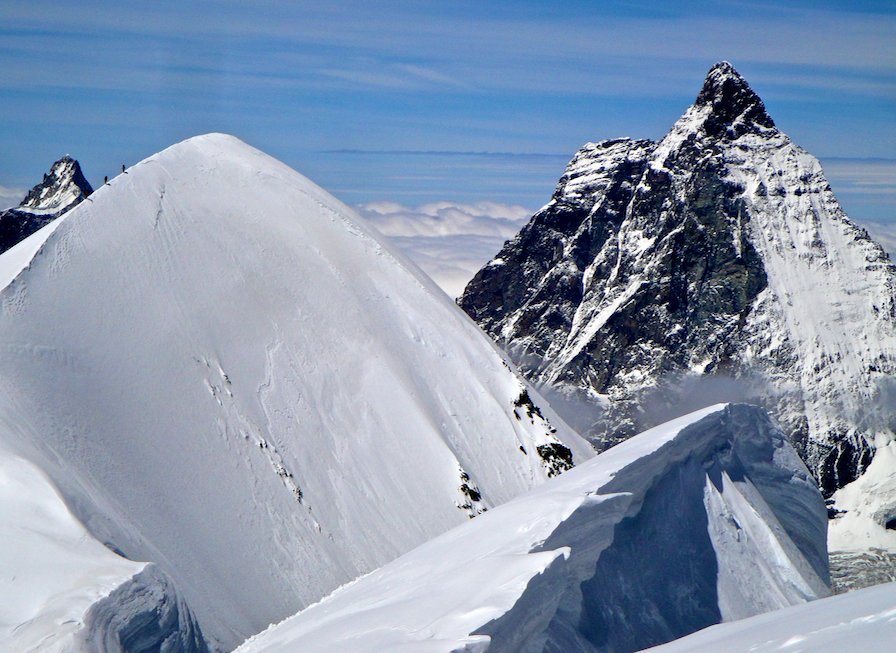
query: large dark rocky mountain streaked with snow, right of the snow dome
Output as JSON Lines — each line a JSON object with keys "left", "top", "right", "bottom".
{"left": 458, "top": 62, "right": 896, "bottom": 494}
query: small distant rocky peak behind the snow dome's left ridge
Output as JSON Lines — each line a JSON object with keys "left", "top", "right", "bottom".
{"left": 0, "top": 155, "right": 93, "bottom": 253}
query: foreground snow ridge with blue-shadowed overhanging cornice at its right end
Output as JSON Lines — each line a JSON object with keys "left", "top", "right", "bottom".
{"left": 238, "top": 405, "right": 827, "bottom": 653}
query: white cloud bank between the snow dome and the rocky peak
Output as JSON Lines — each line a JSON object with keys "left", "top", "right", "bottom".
{"left": 356, "top": 202, "right": 531, "bottom": 297}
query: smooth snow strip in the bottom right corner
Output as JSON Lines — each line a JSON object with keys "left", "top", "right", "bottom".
{"left": 650, "top": 583, "right": 896, "bottom": 653}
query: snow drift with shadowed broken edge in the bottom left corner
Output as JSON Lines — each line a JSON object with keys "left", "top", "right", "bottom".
{"left": 0, "top": 438, "right": 206, "bottom": 653}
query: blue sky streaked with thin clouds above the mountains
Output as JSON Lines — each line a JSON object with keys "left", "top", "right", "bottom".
{"left": 0, "top": 0, "right": 896, "bottom": 220}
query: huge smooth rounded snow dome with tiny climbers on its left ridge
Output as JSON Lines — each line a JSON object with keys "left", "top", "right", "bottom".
{"left": 0, "top": 134, "right": 590, "bottom": 648}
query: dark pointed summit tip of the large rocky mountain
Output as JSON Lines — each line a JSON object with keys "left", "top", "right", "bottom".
{"left": 694, "top": 61, "right": 775, "bottom": 138}
